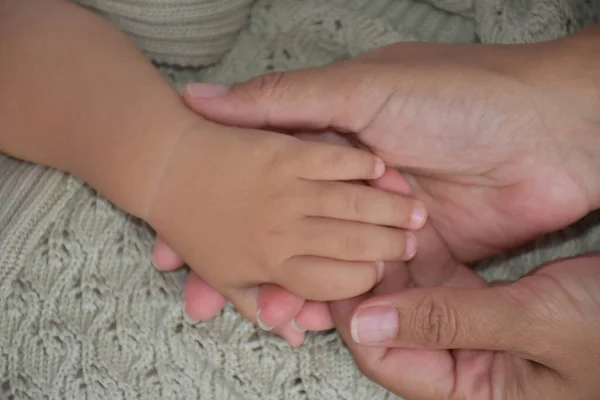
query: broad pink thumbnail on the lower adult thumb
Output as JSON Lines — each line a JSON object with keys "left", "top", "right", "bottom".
{"left": 350, "top": 306, "right": 400, "bottom": 344}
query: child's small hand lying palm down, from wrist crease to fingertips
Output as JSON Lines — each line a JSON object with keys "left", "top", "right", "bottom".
{"left": 147, "top": 121, "right": 425, "bottom": 320}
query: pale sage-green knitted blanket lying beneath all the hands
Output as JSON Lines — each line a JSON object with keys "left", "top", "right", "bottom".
{"left": 0, "top": 0, "right": 600, "bottom": 400}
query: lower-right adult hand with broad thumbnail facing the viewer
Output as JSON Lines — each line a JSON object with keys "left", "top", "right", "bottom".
{"left": 331, "top": 254, "right": 600, "bottom": 400}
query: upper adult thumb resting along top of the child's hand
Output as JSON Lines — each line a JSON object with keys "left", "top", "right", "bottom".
{"left": 184, "top": 62, "right": 392, "bottom": 132}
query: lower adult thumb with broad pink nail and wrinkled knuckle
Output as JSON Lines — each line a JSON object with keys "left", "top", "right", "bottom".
{"left": 351, "top": 286, "right": 545, "bottom": 352}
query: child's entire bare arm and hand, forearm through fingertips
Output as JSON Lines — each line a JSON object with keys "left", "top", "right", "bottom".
{"left": 0, "top": 0, "right": 425, "bottom": 338}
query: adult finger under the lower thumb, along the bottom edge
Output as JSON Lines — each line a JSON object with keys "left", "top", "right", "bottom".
{"left": 331, "top": 290, "right": 572, "bottom": 400}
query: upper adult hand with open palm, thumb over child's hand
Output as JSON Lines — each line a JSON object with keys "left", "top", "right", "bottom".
{"left": 155, "top": 28, "right": 599, "bottom": 344}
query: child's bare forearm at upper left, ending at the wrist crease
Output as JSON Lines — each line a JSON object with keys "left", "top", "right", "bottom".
{"left": 0, "top": 0, "right": 198, "bottom": 216}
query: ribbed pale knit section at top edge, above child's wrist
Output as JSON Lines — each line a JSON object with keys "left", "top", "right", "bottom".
{"left": 74, "top": 0, "right": 252, "bottom": 66}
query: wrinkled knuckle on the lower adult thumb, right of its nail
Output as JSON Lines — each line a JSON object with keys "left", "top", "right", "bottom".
{"left": 412, "top": 295, "right": 458, "bottom": 348}
